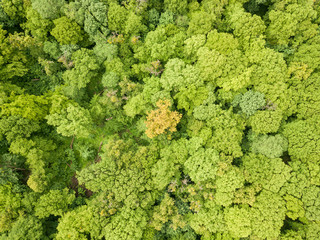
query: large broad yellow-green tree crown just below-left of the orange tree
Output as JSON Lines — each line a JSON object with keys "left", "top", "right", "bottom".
{"left": 77, "top": 139, "right": 157, "bottom": 209}
